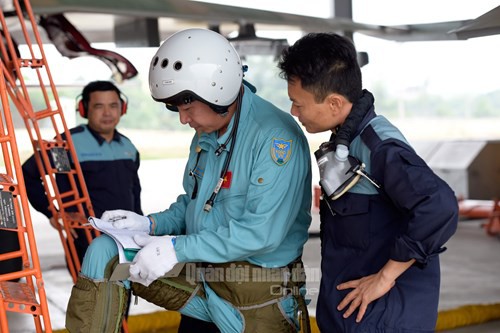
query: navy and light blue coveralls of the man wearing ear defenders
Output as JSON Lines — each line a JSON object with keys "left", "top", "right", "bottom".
{"left": 23, "top": 125, "right": 142, "bottom": 262}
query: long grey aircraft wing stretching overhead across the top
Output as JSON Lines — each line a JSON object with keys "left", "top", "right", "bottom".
{"left": 27, "top": 0, "right": 492, "bottom": 41}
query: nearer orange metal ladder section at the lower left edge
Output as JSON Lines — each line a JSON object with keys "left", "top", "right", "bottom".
{"left": 0, "top": 57, "right": 52, "bottom": 333}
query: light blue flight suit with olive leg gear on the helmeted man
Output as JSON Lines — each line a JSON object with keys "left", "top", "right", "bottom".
{"left": 72, "top": 87, "right": 312, "bottom": 332}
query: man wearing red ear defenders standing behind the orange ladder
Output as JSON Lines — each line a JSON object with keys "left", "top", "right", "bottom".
{"left": 23, "top": 81, "right": 142, "bottom": 268}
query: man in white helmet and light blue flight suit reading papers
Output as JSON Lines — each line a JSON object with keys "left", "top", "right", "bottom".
{"left": 66, "top": 29, "right": 312, "bottom": 333}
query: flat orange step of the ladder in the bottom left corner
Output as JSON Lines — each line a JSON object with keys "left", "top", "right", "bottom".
{"left": 0, "top": 281, "right": 40, "bottom": 314}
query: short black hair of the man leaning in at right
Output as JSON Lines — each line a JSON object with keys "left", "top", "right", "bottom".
{"left": 278, "top": 33, "right": 362, "bottom": 103}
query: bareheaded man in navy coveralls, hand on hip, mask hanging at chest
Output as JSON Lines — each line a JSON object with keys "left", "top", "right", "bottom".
{"left": 278, "top": 33, "right": 458, "bottom": 333}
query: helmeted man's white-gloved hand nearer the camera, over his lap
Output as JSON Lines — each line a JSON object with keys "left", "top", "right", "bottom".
{"left": 129, "top": 234, "right": 179, "bottom": 287}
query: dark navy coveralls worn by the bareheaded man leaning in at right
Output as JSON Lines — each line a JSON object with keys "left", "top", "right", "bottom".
{"left": 316, "top": 103, "right": 458, "bottom": 333}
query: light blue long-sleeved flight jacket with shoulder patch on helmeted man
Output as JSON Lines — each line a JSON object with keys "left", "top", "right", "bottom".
{"left": 151, "top": 83, "right": 312, "bottom": 267}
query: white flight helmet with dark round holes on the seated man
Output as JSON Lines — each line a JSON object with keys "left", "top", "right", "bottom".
{"left": 149, "top": 29, "right": 243, "bottom": 113}
